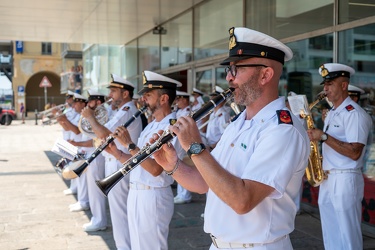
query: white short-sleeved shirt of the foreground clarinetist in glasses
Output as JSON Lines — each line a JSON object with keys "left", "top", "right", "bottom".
{"left": 204, "top": 97, "right": 310, "bottom": 243}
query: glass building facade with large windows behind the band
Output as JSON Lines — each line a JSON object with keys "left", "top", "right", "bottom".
{"left": 83, "top": 0, "right": 375, "bottom": 225}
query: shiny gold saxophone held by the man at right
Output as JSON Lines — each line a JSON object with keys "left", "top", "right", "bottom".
{"left": 300, "top": 93, "right": 327, "bottom": 187}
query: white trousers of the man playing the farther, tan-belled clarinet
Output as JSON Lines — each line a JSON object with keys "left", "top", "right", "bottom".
{"left": 105, "top": 156, "right": 132, "bottom": 250}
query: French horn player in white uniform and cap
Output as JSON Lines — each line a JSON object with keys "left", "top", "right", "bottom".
{"left": 71, "top": 89, "right": 108, "bottom": 232}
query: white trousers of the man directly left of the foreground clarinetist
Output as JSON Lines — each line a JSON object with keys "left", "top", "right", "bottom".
{"left": 128, "top": 187, "right": 174, "bottom": 250}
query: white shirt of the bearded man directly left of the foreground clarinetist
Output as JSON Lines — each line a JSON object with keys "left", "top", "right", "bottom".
{"left": 130, "top": 112, "right": 186, "bottom": 187}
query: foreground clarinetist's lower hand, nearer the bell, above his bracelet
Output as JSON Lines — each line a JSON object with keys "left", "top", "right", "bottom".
{"left": 150, "top": 130, "right": 177, "bottom": 171}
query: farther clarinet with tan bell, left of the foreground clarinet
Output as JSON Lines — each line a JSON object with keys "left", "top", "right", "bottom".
{"left": 66, "top": 106, "right": 147, "bottom": 179}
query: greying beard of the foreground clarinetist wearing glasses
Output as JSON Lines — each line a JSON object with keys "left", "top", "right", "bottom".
{"left": 234, "top": 72, "right": 263, "bottom": 106}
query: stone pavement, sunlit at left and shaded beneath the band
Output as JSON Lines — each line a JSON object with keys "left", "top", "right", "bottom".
{"left": 0, "top": 120, "right": 375, "bottom": 250}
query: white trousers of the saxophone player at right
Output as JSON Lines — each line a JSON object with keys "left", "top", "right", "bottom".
{"left": 318, "top": 173, "right": 364, "bottom": 250}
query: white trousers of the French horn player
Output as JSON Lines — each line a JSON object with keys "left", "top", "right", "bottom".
{"left": 86, "top": 154, "right": 107, "bottom": 227}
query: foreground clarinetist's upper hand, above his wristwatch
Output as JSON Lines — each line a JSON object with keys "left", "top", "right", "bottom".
{"left": 169, "top": 116, "right": 202, "bottom": 151}
